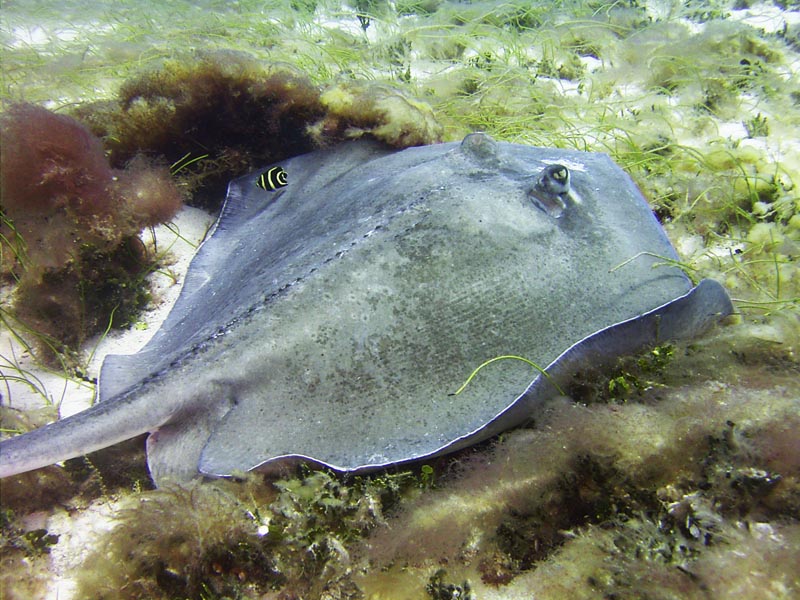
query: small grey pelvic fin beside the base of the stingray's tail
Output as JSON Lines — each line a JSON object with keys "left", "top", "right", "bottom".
{"left": 147, "top": 382, "right": 237, "bottom": 487}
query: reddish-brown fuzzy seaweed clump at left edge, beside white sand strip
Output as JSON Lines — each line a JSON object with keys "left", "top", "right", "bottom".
{"left": 0, "top": 104, "right": 182, "bottom": 358}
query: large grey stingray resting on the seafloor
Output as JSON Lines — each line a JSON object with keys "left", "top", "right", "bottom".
{"left": 0, "top": 134, "right": 732, "bottom": 484}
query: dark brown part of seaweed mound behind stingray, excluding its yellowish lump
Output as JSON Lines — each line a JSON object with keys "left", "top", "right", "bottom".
{"left": 86, "top": 59, "right": 323, "bottom": 204}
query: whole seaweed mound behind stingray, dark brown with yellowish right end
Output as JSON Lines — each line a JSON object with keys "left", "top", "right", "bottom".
{"left": 75, "top": 52, "right": 441, "bottom": 206}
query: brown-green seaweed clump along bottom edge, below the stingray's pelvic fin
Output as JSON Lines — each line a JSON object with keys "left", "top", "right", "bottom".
{"left": 70, "top": 470, "right": 415, "bottom": 600}
